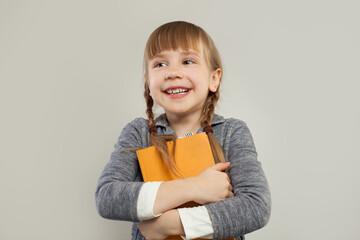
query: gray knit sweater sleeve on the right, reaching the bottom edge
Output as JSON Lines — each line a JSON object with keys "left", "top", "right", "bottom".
{"left": 204, "top": 121, "right": 271, "bottom": 239}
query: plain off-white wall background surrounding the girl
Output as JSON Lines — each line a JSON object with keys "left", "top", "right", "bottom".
{"left": 0, "top": 0, "right": 360, "bottom": 240}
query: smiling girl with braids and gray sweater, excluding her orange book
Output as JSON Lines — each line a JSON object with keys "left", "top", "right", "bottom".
{"left": 96, "top": 21, "right": 271, "bottom": 239}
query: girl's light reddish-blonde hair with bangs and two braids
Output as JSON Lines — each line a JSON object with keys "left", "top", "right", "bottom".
{"left": 144, "top": 21, "right": 225, "bottom": 174}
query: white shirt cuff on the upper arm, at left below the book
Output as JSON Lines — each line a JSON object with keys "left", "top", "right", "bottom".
{"left": 137, "top": 182, "right": 162, "bottom": 221}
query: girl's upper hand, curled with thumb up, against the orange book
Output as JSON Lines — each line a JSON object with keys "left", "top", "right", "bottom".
{"left": 191, "top": 162, "right": 234, "bottom": 204}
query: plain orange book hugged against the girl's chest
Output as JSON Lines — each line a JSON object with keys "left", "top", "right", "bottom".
{"left": 136, "top": 132, "right": 235, "bottom": 240}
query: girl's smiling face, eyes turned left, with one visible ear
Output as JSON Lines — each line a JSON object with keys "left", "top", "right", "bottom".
{"left": 147, "top": 42, "right": 221, "bottom": 117}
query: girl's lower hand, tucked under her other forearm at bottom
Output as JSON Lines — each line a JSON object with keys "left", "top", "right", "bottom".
{"left": 137, "top": 209, "right": 185, "bottom": 240}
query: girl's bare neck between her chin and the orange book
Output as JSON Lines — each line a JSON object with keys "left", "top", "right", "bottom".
{"left": 166, "top": 111, "right": 201, "bottom": 137}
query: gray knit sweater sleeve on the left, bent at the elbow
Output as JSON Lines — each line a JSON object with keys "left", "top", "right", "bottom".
{"left": 95, "top": 119, "right": 143, "bottom": 222}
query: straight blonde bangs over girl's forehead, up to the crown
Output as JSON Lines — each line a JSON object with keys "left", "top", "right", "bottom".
{"left": 144, "top": 22, "right": 203, "bottom": 61}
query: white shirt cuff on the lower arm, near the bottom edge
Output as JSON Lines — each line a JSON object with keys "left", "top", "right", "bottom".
{"left": 178, "top": 206, "right": 214, "bottom": 240}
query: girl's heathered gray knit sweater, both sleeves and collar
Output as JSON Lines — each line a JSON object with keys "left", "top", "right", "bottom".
{"left": 95, "top": 114, "right": 271, "bottom": 240}
